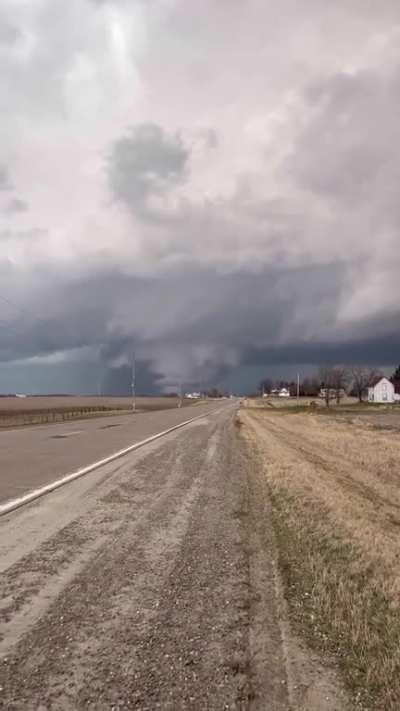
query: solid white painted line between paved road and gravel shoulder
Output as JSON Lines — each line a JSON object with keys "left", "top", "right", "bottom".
{"left": 0, "top": 408, "right": 223, "bottom": 516}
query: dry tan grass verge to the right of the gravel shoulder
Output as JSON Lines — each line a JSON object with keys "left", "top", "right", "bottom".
{"left": 242, "top": 409, "right": 400, "bottom": 711}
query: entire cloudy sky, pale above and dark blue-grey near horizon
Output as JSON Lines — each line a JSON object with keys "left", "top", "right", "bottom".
{"left": 0, "top": 0, "right": 400, "bottom": 392}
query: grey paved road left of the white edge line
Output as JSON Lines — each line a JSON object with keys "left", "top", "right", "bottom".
{"left": 0, "top": 403, "right": 218, "bottom": 503}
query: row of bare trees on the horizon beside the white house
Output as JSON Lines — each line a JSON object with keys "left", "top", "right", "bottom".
{"left": 259, "top": 365, "right": 400, "bottom": 407}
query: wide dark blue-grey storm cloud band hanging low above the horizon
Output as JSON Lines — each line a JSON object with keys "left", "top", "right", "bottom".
{"left": 1, "top": 256, "right": 400, "bottom": 384}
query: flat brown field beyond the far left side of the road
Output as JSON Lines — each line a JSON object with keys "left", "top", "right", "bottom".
{"left": 0, "top": 396, "right": 196, "bottom": 427}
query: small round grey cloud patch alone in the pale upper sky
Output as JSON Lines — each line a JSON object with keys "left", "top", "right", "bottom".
{"left": 108, "top": 123, "right": 188, "bottom": 210}
